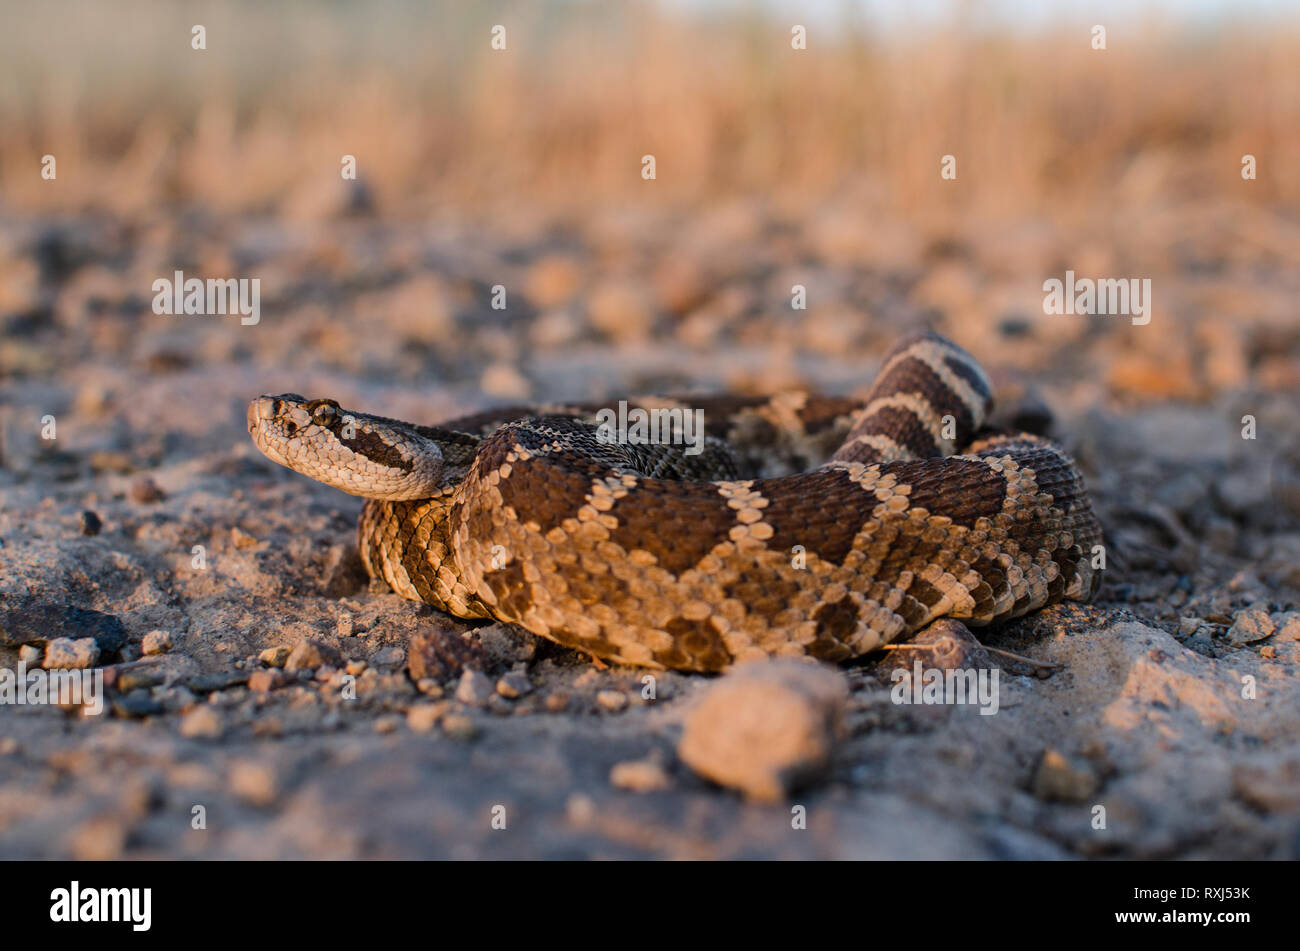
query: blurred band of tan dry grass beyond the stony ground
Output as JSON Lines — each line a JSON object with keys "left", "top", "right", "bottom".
{"left": 0, "top": 0, "right": 1300, "bottom": 223}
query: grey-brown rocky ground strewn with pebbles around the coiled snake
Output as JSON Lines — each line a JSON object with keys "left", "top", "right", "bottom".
{"left": 0, "top": 202, "right": 1300, "bottom": 859}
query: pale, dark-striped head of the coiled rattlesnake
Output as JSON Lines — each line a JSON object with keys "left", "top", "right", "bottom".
{"left": 248, "top": 392, "right": 443, "bottom": 501}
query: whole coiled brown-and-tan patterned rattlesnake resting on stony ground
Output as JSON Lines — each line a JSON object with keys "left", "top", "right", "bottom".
{"left": 248, "top": 333, "right": 1101, "bottom": 670}
